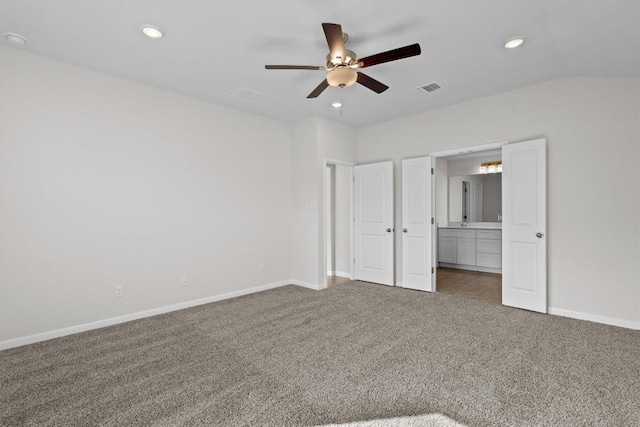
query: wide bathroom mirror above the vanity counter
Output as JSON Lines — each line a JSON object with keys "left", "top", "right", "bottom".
{"left": 449, "top": 173, "right": 502, "bottom": 222}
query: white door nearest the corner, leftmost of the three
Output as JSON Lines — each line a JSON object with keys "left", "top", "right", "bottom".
{"left": 353, "top": 162, "right": 394, "bottom": 286}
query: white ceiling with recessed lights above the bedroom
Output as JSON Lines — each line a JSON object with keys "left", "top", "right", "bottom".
{"left": 0, "top": 0, "right": 640, "bottom": 127}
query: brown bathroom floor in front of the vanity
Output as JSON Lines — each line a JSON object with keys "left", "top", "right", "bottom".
{"left": 436, "top": 267, "right": 502, "bottom": 304}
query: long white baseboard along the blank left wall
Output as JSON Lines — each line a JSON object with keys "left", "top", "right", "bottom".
{"left": 0, "top": 280, "right": 292, "bottom": 350}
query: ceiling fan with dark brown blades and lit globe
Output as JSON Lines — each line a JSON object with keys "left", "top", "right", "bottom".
{"left": 264, "top": 22, "right": 421, "bottom": 98}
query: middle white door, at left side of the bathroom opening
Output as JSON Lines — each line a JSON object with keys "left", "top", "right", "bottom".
{"left": 402, "top": 157, "right": 433, "bottom": 292}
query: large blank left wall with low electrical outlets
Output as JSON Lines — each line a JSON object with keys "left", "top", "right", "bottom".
{"left": 0, "top": 47, "right": 292, "bottom": 341}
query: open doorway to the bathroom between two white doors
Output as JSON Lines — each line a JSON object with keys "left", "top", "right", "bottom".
{"left": 434, "top": 148, "right": 502, "bottom": 304}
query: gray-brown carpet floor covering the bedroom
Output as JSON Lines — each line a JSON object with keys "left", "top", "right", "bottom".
{"left": 0, "top": 282, "right": 640, "bottom": 426}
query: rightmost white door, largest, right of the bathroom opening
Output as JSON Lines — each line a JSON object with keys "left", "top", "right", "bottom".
{"left": 502, "top": 139, "right": 547, "bottom": 313}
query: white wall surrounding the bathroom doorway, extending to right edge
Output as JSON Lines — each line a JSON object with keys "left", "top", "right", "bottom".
{"left": 358, "top": 77, "right": 640, "bottom": 324}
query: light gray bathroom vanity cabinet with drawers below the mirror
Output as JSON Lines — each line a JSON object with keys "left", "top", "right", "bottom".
{"left": 438, "top": 227, "right": 502, "bottom": 273}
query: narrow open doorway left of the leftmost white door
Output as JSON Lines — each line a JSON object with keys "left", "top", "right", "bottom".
{"left": 324, "top": 161, "right": 353, "bottom": 286}
